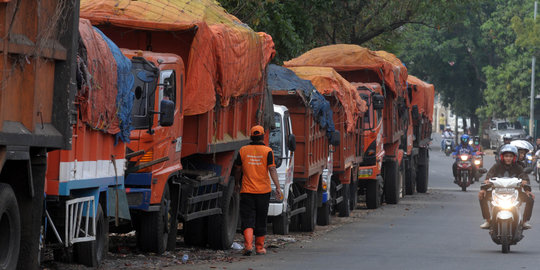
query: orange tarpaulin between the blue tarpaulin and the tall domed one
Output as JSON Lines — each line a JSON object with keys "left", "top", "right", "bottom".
{"left": 289, "top": 67, "right": 367, "bottom": 132}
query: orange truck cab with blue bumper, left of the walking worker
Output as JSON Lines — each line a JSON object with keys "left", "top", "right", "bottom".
{"left": 122, "top": 49, "right": 184, "bottom": 253}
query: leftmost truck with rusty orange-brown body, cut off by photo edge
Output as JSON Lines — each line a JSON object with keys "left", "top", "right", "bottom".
{"left": 0, "top": 0, "right": 79, "bottom": 269}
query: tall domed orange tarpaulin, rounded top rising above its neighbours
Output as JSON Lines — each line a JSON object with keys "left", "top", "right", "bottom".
{"left": 284, "top": 44, "right": 407, "bottom": 95}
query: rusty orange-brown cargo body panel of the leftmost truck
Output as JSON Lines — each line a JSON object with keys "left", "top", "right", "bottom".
{"left": 0, "top": 0, "right": 78, "bottom": 148}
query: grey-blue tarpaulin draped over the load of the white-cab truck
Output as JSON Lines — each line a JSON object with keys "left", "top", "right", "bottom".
{"left": 266, "top": 64, "right": 336, "bottom": 138}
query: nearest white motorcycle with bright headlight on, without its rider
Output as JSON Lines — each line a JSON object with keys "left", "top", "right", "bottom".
{"left": 482, "top": 177, "right": 530, "bottom": 253}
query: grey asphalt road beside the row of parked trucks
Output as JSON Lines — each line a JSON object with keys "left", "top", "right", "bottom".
{"left": 187, "top": 134, "right": 540, "bottom": 270}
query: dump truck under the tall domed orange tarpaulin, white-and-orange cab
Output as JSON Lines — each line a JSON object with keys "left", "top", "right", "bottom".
{"left": 285, "top": 44, "right": 409, "bottom": 208}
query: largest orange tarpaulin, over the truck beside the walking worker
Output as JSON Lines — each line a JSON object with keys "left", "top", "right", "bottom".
{"left": 80, "top": 0, "right": 275, "bottom": 115}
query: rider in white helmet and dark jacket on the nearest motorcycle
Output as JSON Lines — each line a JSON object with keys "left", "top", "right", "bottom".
{"left": 478, "top": 145, "right": 534, "bottom": 230}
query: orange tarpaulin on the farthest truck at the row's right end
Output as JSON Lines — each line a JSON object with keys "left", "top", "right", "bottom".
{"left": 407, "top": 75, "right": 435, "bottom": 122}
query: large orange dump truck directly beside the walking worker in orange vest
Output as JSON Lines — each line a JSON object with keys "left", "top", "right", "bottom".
{"left": 81, "top": 0, "right": 274, "bottom": 253}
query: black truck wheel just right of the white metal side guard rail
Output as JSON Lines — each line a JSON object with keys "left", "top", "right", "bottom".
{"left": 74, "top": 203, "right": 109, "bottom": 268}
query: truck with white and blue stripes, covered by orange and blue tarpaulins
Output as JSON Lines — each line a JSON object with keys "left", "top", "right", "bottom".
{"left": 42, "top": 19, "right": 134, "bottom": 267}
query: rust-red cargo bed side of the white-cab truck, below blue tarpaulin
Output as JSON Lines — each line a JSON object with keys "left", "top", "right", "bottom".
{"left": 272, "top": 91, "right": 328, "bottom": 180}
